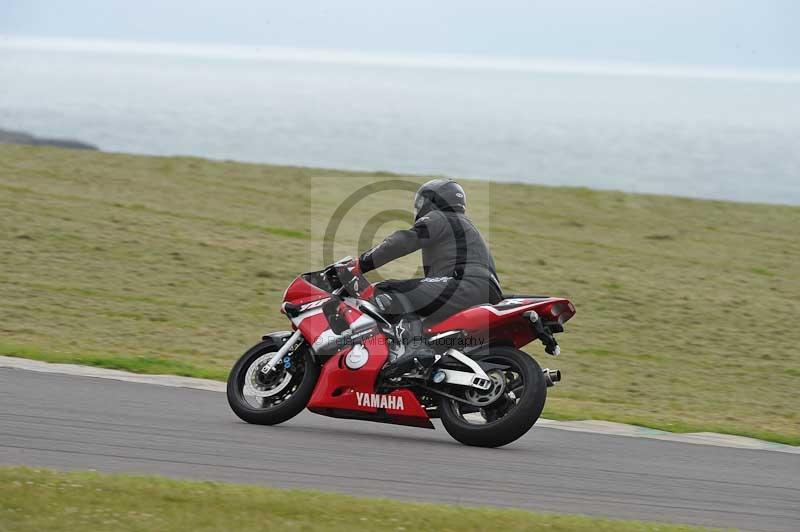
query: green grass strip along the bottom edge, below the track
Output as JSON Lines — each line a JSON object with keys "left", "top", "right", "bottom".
{"left": 0, "top": 467, "right": 712, "bottom": 532}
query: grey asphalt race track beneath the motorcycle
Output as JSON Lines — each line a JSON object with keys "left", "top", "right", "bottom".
{"left": 0, "top": 368, "right": 800, "bottom": 530}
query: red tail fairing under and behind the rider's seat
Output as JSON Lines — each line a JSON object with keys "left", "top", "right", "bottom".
{"left": 426, "top": 297, "right": 575, "bottom": 348}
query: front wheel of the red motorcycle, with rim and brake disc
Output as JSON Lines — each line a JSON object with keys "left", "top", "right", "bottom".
{"left": 228, "top": 340, "right": 319, "bottom": 425}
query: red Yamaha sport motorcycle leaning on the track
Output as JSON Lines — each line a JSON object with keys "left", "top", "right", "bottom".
{"left": 228, "top": 258, "right": 575, "bottom": 447}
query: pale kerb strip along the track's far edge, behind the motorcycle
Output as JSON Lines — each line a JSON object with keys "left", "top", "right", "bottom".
{"left": 0, "top": 355, "right": 800, "bottom": 454}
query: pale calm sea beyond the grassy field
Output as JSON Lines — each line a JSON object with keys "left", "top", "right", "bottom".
{"left": 0, "top": 40, "right": 800, "bottom": 204}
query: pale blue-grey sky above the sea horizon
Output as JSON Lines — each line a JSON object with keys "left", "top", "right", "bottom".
{"left": 0, "top": 0, "right": 800, "bottom": 70}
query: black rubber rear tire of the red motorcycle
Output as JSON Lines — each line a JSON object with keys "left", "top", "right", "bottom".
{"left": 439, "top": 347, "right": 547, "bottom": 447}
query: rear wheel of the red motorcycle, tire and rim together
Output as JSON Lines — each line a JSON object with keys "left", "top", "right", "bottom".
{"left": 439, "top": 347, "right": 547, "bottom": 447}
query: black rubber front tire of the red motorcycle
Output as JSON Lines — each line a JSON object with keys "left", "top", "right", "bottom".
{"left": 228, "top": 340, "right": 319, "bottom": 425}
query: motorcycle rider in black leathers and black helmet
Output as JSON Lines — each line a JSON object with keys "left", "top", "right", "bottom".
{"left": 355, "top": 179, "right": 503, "bottom": 378}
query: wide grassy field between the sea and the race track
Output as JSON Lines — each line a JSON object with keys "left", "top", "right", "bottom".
{"left": 0, "top": 145, "right": 800, "bottom": 445}
